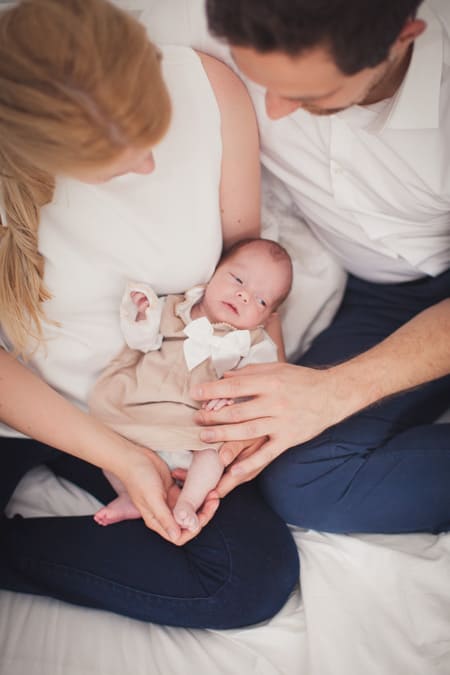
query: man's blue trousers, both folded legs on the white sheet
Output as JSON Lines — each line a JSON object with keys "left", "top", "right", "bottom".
{"left": 260, "top": 272, "right": 450, "bottom": 533}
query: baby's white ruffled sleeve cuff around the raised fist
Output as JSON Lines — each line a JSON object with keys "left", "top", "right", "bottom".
{"left": 120, "top": 282, "right": 165, "bottom": 353}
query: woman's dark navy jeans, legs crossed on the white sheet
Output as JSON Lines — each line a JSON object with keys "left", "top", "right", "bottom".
{"left": 0, "top": 438, "right": 299, "bottom": 628}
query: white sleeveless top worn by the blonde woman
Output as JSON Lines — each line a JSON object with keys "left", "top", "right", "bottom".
{"left": 0, "top": 47, "right": 222, "bottom": 434}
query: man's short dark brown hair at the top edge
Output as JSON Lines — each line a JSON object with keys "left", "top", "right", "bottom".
{"left": 206, "top": 0, "right": 422, "bottom": 75}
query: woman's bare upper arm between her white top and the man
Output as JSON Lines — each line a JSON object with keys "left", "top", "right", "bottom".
{"left": 199, "top": 53, "right": 260, "bottom": 249}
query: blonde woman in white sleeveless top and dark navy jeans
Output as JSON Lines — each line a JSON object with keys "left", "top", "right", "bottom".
{"left": 0, "top": 0, "right": 298, "bottom": 628}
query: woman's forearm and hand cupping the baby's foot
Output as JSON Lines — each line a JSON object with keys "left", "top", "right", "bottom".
{"left": 0, "top": 349, "right": 215, "bottom": 544}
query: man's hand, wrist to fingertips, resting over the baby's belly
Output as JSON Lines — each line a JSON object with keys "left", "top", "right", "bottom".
{"left": 191, "top": 363, "right": 353, "bottom": 478}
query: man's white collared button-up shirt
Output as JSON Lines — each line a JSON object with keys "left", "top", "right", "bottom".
{"left": 246, "top": 0, "right": 450, "bottom": 283}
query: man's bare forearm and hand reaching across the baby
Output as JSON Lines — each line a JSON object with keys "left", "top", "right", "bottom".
{"left": 191, "top": 299, "right": 450, "bottom": 484}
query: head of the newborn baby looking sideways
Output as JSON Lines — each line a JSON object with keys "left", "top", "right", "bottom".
{"left": 202, "top": 245, "right": 286, "bottom": 329}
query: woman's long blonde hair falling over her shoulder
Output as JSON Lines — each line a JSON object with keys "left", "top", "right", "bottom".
{"left": 0, "top": 0, "right": 170, "bottom": 354}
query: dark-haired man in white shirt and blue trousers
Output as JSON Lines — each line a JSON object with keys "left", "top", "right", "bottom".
{"left": 194, "top": 0, "right": 450, "bottom": 532}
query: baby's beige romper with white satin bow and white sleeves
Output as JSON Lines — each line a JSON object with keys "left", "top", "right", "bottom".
{"left": 89, "top": 284, "right": 277, "bottom": 466}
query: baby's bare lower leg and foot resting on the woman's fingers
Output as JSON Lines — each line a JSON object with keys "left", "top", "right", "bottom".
{"left": 173, "top": 448, "right": 223, "bottom": 532}
